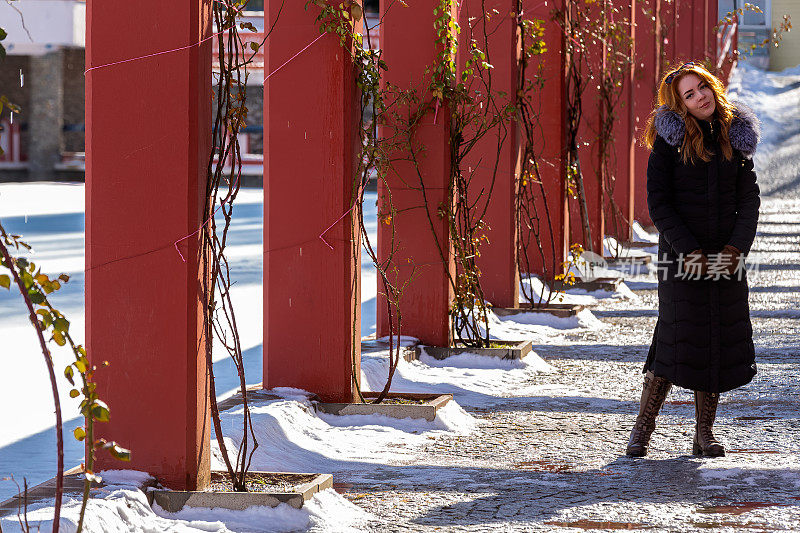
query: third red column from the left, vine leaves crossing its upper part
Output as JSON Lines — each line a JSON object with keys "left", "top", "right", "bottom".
{"left": 377, "top": 0, "right": 457, "bottom": 346}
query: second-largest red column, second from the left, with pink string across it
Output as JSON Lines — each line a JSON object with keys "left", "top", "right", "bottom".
{"left": 264, "top": 0, "right": 361, "bottom": 402}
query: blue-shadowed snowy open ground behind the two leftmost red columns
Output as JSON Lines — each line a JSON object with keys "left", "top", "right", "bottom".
{"left": 0, "top": 183, "right": 263, "bottom": 500}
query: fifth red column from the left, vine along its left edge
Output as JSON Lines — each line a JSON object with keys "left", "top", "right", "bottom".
{"left": 520, "top": 0, "right": 570, "bottom": 279}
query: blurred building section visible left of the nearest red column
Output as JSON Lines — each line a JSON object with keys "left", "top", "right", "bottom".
{"left": 0, "top": 0, "right": 86, "bottom": 180}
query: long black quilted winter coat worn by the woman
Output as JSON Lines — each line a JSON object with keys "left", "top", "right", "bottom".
{"left": 644, "top": 104, "right": 760, "bottom": 392}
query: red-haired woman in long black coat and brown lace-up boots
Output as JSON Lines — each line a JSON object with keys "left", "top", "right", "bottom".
{"left": 626, "top": 62, "right": 761, "bottom": 457}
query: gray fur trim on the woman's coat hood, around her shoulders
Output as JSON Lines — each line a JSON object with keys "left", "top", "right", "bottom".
{"left": 655, "top": 102, "right": 761, "bottom": 158}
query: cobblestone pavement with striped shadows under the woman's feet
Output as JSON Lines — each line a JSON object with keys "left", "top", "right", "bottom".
{"left": 335, "top": 199, "right": 800, "bottom": 531}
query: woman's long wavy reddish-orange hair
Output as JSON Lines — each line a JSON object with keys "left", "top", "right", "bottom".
{"left": 644, "top": 62, "right": 735, "bottom": 164}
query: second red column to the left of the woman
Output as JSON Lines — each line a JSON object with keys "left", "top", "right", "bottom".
{"left": 606, "top": 0, "right": 637, "bottom": 241}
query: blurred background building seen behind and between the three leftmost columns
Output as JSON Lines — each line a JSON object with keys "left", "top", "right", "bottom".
{"left": 0, "top": 0, "right": 378, "bottom": 184}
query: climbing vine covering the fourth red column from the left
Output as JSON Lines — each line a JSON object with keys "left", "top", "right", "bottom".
{"left": 424, "top": 0, "right": 517, "bottom": 347}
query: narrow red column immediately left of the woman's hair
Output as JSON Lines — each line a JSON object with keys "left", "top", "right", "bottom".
{"left": 631, "top": 0, "right": 661, "bottom": 227}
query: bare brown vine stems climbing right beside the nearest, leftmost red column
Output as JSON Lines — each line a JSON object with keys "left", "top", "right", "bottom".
{"left": 200, "top": 0, "right": 285, "bottom": 492}
